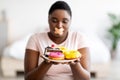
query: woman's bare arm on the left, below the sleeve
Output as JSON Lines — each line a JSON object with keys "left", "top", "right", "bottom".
{"left": 24, "top": 49, "right": 52, "bottom": 80}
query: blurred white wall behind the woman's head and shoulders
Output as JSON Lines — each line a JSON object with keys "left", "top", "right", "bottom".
{"left": 0, "top": 0, "right": 120, "bottom": 43}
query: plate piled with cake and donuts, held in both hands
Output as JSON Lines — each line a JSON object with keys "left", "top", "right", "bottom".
{"left": 42, "top": 44, "right": 81, "bottom": 63}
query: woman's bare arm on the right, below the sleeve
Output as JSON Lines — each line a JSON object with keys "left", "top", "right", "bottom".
{"left": 70, "top": 48, "right": 90, "bottom": 80}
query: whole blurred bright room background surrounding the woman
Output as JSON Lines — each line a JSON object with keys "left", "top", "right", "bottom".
{"left": 0, "top": 0, "right": 120, "bottom": 80}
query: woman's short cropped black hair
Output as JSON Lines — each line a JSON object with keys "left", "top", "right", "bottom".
{"left": 48, "top": 1, "right": 72, "bottom": 17}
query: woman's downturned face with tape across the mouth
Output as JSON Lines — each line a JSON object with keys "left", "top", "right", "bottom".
{"left": 49, "top": 10, "right": 71, "bottom": 37}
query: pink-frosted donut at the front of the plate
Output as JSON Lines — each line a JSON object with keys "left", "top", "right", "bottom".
{"left": 49, "top": 52, "right": 64, "bottom": 60}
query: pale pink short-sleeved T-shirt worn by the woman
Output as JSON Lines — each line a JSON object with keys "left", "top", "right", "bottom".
{"left": 26, "top": 32, "right": 88, "bottom": 80}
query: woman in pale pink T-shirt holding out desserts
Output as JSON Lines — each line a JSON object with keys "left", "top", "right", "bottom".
{"left": 24, "top": 1, "right": 90, "bottom": 80}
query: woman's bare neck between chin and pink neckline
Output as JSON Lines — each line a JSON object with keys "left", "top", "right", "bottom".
{"left": 48, "top": 32, "right": 68, "bottom": 44}
